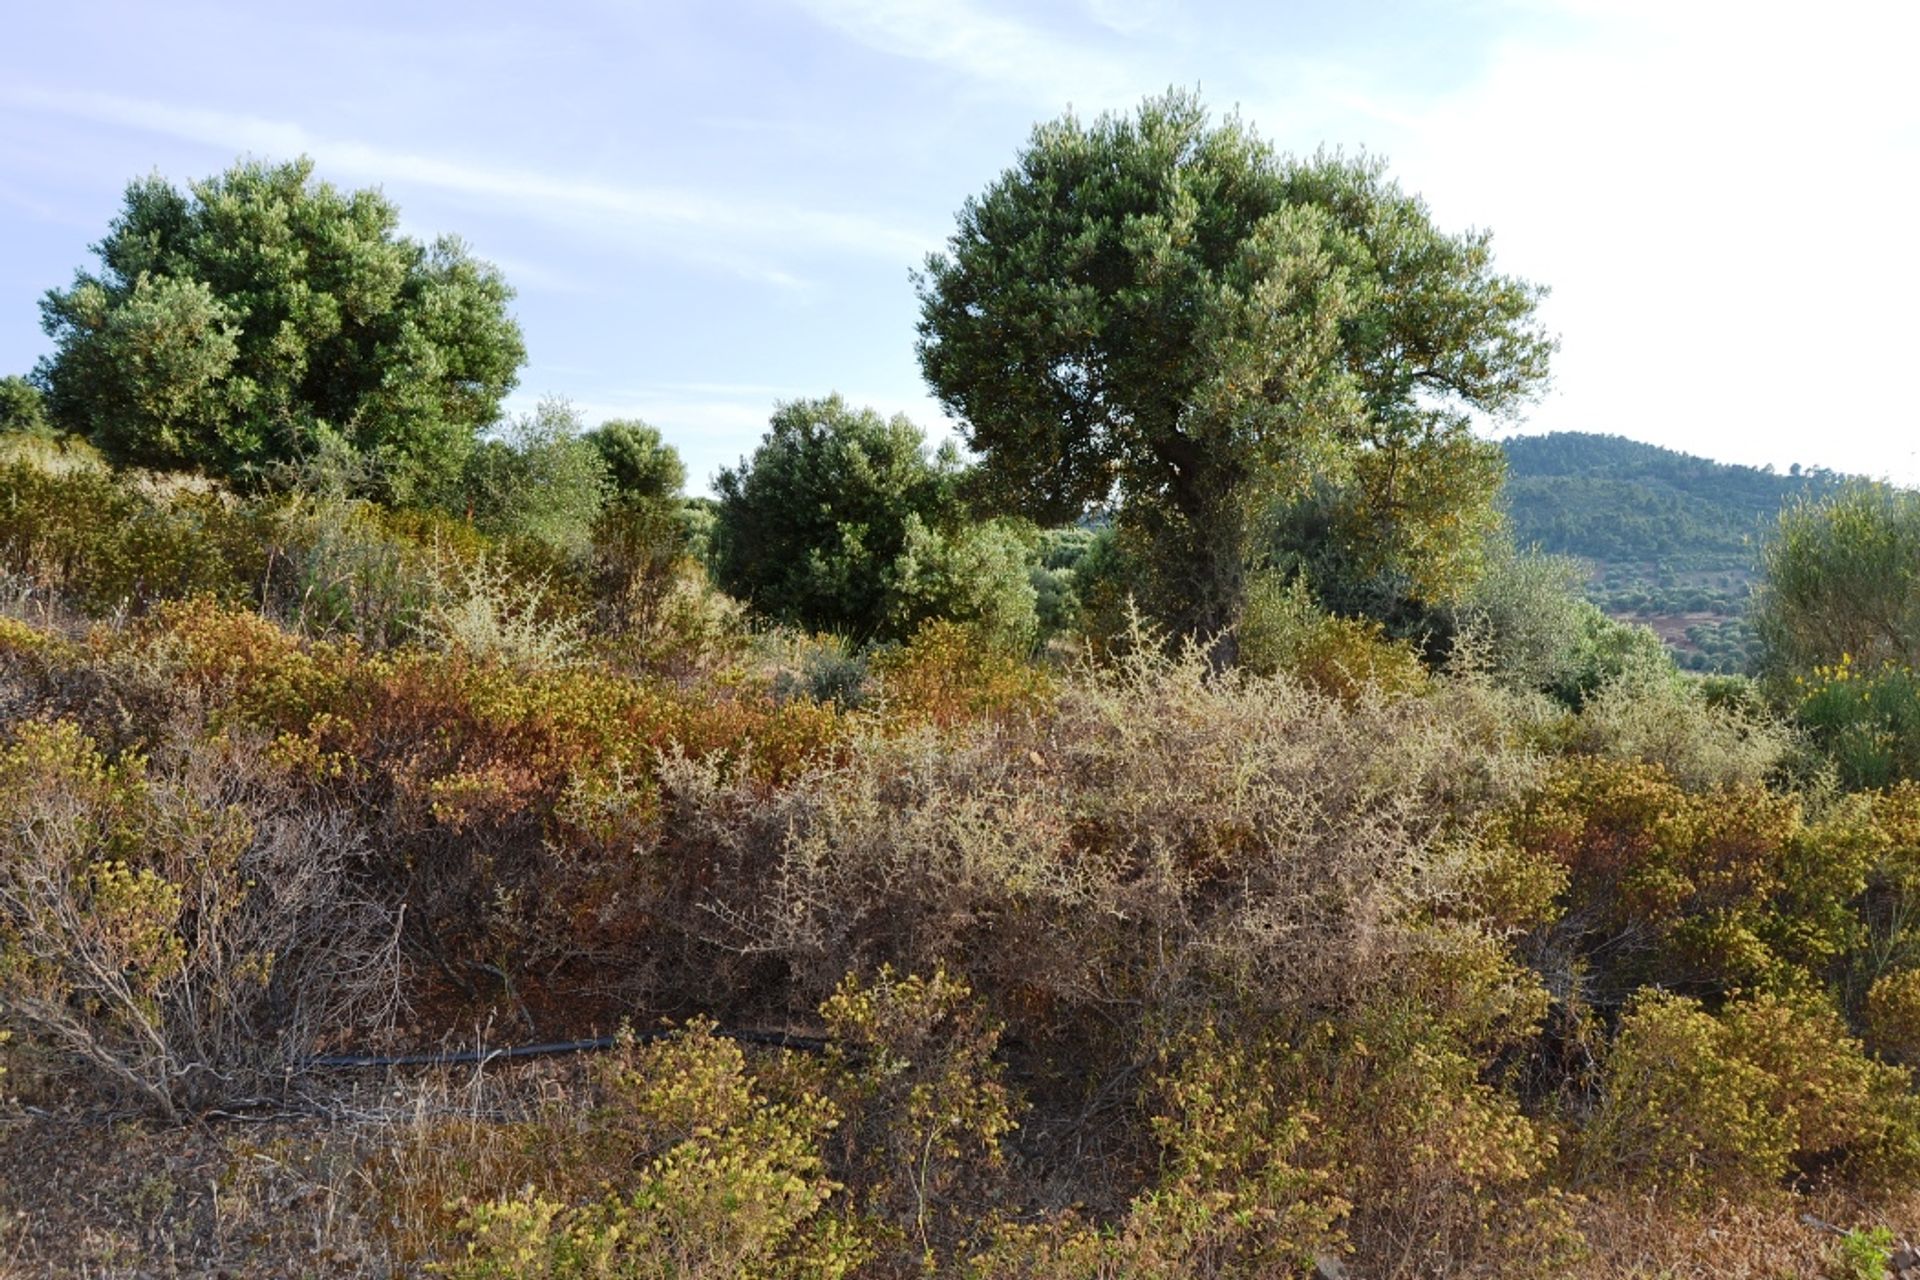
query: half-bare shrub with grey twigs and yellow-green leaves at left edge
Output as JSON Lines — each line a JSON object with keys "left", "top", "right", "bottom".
{"left": 0, "top": 722, "right": 397, "bottom": 1121}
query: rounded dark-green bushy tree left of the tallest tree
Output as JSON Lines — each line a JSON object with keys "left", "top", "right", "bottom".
{"left": 712, "top": 395, "right": 1035, "bottom": 647}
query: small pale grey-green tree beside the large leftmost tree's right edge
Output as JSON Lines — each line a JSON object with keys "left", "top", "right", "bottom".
{"left": 467, "top": 399, "right": 611, "bottom": 558}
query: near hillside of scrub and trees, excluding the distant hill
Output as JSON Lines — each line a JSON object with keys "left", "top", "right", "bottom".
{"left": 0, "top": 87, "right": 1920, "bottom": 1280}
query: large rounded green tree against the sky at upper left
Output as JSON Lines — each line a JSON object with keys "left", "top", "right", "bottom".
{"left": 36, "top": 159, "right": 526, "bottom": 499}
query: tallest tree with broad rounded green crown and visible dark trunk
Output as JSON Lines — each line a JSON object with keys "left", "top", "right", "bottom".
{"left": 920, "top": 92, "right": 1553, "bottom": 660}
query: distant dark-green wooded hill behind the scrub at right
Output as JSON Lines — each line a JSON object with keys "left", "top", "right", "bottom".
{"left": 1503, "top": 432, "right": 1845, "bottom": 670}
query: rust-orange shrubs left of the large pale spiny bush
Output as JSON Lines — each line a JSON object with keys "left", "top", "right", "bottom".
{"left": 0, "top": 599, "right": 841, "bottom": 994}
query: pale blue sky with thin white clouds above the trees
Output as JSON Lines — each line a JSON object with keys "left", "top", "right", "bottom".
{"left": 0, "top": 0, "right": 1920, "bottom": 489}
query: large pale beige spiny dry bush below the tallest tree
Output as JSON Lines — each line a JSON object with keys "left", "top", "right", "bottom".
{"left": 698, "top": 649, "right": 1536, "bottom": 1063}
